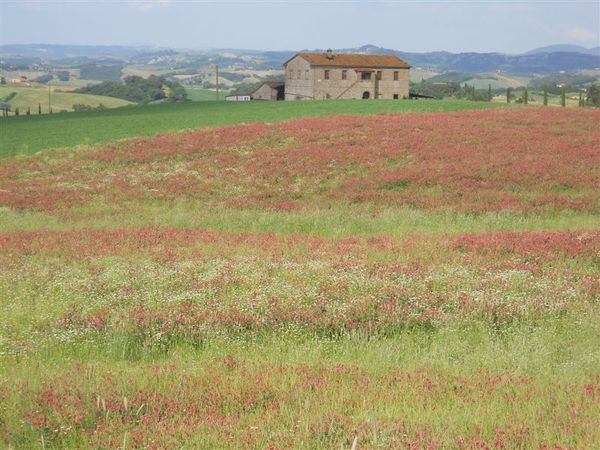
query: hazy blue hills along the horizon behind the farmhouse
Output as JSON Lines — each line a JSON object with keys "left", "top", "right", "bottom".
{"left": 0, "top": 44, "right": 600, "bottom": 74}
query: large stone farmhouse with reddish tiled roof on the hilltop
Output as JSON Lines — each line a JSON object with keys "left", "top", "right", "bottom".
{"left": 284, "top": 50, "right": 410, "bottom": 100}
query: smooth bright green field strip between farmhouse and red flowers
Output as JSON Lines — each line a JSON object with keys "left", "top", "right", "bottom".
{"left": 0, "top": 100, "right": 510, "bottom": 157}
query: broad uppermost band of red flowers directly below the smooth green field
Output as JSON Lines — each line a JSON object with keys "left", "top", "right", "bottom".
{"left": 0, "top": 109, "right": 600, "bottom": 213}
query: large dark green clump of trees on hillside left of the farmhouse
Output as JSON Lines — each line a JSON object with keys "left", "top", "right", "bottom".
{"left": 75, "top": 75, "right": 187, "bottom": 103}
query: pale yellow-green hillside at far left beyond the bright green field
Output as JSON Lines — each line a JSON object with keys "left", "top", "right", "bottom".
{"left": 0, "top": 86, "right": 132, "bottom": 115}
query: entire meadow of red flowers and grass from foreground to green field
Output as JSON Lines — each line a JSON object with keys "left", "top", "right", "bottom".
{"left": 0, "top": 107, "right": 600, "bottom": 449}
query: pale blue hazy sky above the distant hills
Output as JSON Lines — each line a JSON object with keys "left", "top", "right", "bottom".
{"left": 0, "top": 0, "right": 600, "bottom": 54}
